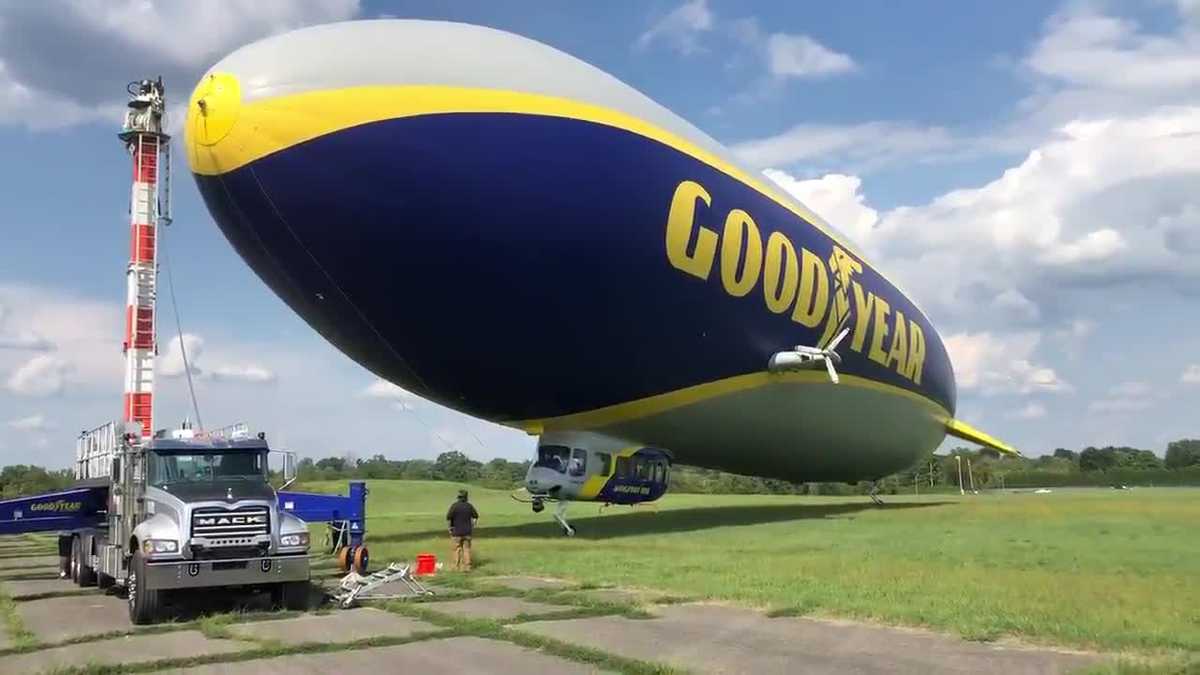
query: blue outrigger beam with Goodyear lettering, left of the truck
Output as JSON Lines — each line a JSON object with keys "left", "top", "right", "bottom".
{"left": 0, "top": 485, "right": 108, "bottom": 534}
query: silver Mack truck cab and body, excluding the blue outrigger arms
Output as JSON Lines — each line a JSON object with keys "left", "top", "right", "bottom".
{"left": 69, "top": 423, "right": 310, "bottom": 623}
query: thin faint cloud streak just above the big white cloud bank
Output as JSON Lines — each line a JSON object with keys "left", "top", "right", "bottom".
{"left": 732, "top": 121, "right": 955, "bottom": 169}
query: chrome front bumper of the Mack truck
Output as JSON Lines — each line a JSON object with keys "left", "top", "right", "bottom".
{"left": 143, "top": 555, "right": 310, "bottom": 590}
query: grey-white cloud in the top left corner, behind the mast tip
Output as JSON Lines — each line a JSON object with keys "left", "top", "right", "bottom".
{"left": 0, "top": 0, "right": 359, "bottom": 130}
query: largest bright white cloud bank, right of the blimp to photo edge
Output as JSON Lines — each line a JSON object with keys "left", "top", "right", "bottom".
{"left": 868, "top": 107, "right": 1200, "bottom": 324}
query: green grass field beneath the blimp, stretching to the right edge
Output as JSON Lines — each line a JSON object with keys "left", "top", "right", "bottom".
{"left": 304, "top": 480, "right": 1200, "bottom": 652}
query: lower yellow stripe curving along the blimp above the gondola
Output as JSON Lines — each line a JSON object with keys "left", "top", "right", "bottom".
{"left": 505, "top": 371, "right": 952, "bottom": 435}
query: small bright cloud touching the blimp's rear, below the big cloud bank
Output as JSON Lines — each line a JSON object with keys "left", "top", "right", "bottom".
{"left": 944, "top": 333, "right": 1070, "bottom": 394}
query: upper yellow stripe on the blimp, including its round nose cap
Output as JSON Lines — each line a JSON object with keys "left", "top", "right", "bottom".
{"left": 185, "top": 73, "right": 863, "bottom": 259}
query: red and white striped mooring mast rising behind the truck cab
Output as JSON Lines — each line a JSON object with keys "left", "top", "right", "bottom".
{"left": 118, "top": 78, "right": 170, "bottom": 438}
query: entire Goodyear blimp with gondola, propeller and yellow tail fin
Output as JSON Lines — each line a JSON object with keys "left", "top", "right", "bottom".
{"left": 186, "top": 20, "right": 1015, "bottom": 533}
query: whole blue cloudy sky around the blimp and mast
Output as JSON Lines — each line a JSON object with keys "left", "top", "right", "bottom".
{"left": 0, "top": 0, "right": 1200, "bottom": 466}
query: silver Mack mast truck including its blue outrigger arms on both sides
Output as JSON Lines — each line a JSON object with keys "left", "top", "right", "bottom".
{"left": 0, "top": 422, "right": 370, "bottom": 625}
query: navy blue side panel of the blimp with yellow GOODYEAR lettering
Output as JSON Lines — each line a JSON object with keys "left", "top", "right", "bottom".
{"left": 197, "top": 113, "right": 955, "bottom": 420}
